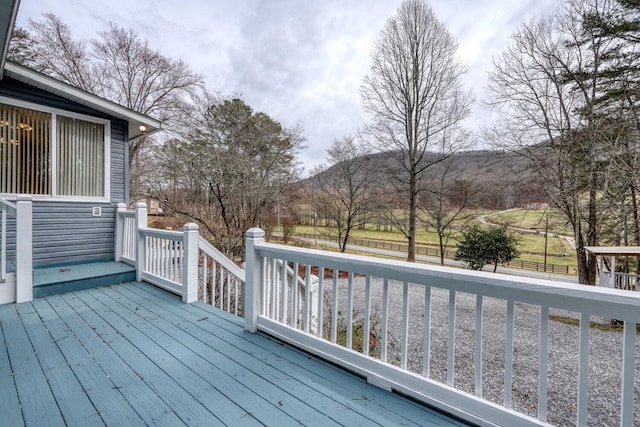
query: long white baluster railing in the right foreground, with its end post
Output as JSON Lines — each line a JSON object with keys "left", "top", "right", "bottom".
{"left": 245, "top": 229, "right": 640, "bottom": 427}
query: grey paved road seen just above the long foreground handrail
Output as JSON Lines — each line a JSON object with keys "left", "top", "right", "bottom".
{"left": 297, "top": 237, "right": 578, "bottom": 283}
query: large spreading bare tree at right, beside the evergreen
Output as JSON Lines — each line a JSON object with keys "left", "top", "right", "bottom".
{"left": 488, "top": 0, "right": 632, "bottom": 284}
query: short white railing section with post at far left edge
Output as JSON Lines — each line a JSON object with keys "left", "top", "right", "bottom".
{"left": 0, "top": 194, "right": 33, "bottom": 303}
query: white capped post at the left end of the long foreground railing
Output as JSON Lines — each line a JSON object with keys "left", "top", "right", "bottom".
{"left": 244, "top": 228, "right": 264, "bottom": 333}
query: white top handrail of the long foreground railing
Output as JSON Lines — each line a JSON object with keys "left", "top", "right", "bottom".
{"left": 255, "top": 243, "right": 640, "bottom": 322}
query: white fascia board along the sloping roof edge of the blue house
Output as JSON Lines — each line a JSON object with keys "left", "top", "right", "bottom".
{"left": 5, "top": 61, "right": 162, "bottom": 140}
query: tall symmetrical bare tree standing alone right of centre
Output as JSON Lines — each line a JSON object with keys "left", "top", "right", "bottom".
{"left": 361, "top": 0, "right": 472, "bottom": 261}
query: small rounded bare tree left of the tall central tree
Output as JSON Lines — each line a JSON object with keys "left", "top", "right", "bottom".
{"left": 310, "top": 135, "right": 379, "bottom": 252}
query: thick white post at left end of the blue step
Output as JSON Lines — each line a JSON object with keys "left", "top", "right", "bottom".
{"left": 16, "top": 194, "right": 33, "bottom": 302}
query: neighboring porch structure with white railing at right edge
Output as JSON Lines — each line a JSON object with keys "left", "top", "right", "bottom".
{"left": 585, "top": 246, "right": 640, "bottom": 291}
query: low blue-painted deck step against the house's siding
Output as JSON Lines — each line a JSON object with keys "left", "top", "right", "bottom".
{"left": 33, "top": 261, "right": 136, "bottom": 298}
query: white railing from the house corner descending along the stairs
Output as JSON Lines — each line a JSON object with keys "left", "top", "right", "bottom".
{"left": 115, "top": 203, "right": 318, "bottom": 322}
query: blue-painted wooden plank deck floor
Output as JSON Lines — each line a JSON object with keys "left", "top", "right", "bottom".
{"left": 0, "top": 282, "right": 465, "bottom": 426}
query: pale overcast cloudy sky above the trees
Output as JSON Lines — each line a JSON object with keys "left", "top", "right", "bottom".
{"left": 17, "top": 0, "right": 559, "bottom": 176}
